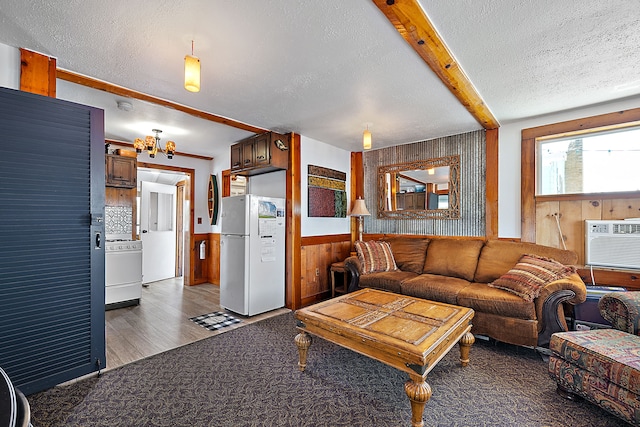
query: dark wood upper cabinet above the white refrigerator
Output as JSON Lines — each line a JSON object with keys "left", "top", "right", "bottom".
{"left": 231, "top": 132, "right": 289, "bottom": 176}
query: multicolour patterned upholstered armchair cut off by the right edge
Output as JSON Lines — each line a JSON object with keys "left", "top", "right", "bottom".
{"left": 549, "top": 292, "right": 640, "bottom": 426}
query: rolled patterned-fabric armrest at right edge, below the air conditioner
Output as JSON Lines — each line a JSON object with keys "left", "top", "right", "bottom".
{"left": 598, "top": 291, "right": 640, "bottom": 335}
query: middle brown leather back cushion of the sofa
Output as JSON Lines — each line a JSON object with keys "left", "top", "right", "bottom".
{"left": 422, "top": 239, "right": 484, "bottom": 281}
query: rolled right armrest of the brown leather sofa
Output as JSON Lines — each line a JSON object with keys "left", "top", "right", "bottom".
{"left": 535, "top": 273, "right": 587, "bottom": 347}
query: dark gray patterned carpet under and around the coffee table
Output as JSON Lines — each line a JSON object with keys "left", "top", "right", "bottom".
{"left": 28, "top": 313, "right": 624, "bottom": 427}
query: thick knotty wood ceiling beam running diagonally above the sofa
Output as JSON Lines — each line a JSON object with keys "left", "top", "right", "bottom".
{"left": 373, "top": 0, "right": 500, "bottom": 129}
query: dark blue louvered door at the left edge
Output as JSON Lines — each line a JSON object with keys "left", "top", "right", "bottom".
{"left": 0, "top": 88, "right": 105, "bottom": 395}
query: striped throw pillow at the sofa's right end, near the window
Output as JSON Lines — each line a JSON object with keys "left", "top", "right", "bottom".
{"left": 489, "top": 255, "right": 576, "bottom": 301}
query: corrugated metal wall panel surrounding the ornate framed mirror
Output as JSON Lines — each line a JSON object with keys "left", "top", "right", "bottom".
{"left": 363, "top": 130, "right": 486, "bottom": 236}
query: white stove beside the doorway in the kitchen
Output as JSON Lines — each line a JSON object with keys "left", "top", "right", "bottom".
{"left": 104, "top": 239, "right": 142, "bottom": 310}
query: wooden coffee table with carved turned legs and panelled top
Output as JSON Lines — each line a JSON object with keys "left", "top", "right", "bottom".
{"left": 295, "top": 289, "right": 475, "bottom": 426}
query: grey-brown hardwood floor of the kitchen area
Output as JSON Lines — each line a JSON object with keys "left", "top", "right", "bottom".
{"left": 106, "top": 278, "right": 289, "bottom": 370}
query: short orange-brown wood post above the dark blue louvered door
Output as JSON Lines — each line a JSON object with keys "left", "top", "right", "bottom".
{"left": 20, "top": 48, "right": 57, "bottom": 98}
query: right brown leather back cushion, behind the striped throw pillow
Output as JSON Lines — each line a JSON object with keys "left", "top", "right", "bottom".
{"left": 473, "top": 240, "right": 578, "bottom": 283}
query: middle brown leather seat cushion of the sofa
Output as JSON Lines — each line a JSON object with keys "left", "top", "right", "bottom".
{"left": 400, "top": 274, "right": 469, "bottom": 305}
